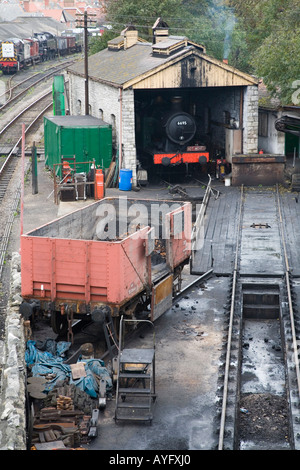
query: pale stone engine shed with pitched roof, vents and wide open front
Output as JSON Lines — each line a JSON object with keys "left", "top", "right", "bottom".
{"left": 68, "top": 19, "right": 258, "bottom": 183}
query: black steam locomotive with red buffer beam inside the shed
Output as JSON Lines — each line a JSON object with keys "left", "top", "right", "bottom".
{"left": 137, "top": 96, "right": 209, "bottom": 168}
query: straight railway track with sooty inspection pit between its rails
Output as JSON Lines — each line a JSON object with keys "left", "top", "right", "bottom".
{"left": 218, "top": 187, "right": 300, "bottom": 450}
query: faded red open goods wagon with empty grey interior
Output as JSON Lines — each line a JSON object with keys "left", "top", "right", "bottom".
{"left": 21, "top": 198, "right": 191, "bottom": 333}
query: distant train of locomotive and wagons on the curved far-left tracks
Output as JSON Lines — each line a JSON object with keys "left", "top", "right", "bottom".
{"left": 0, "top": 32, "right": 83, "bottom": 74}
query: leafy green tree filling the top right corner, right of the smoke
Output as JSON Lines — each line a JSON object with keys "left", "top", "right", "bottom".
{"left": 231, "top": 0, "right": 300, "bottom": 104}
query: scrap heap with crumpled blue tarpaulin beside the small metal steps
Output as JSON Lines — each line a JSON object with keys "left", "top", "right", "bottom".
{"left": 25, "top": 340, "right": 112, "bottom": 450}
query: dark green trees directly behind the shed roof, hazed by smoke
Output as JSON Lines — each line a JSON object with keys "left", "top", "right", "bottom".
{"left": 86, "top": 0, "right": 258, "bottom": 72}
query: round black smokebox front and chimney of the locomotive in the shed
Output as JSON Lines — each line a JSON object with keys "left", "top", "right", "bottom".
{"left": 165, "top": 96, "right": 196, "bottom": 146}
